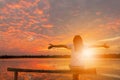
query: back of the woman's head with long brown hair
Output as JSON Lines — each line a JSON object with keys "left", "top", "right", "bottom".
{"left": 73, "top": 35, "right": 83, "bottom": 50}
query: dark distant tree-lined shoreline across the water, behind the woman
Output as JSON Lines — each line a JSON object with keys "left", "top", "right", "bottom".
{"left": 0, "top": 54, "right": 120, "bottom": 59}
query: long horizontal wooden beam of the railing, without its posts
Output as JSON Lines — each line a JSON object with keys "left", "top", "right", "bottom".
{"left": 7, "top": 68, "right": 96, "bottom": 74}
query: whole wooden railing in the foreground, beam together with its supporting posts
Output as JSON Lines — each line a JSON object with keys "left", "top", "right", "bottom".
{"left": 7, "top": 68, "right": 96, "bottom": 80}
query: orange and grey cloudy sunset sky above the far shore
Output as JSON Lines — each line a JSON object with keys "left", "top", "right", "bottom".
{"left": 0, "top": 0, "right": 120, "bottom": 55}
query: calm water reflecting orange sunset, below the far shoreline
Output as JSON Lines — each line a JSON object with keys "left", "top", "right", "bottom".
{"left": 0, "top": 59, "right": 120, "bottom": 80}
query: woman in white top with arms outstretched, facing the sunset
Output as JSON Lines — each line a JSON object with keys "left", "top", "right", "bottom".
{"left": 48, "top": 35, "right": 108, "bottom": 80}
